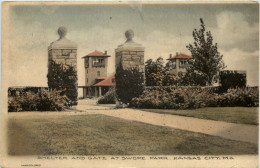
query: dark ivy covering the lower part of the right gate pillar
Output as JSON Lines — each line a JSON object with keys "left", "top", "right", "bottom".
{"left": 115, "top": 64, "right": 144, "bottom": 104}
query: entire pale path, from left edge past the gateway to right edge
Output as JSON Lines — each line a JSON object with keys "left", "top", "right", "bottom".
{"left": 9, "top": 100, "right": 258, "bottom": 144}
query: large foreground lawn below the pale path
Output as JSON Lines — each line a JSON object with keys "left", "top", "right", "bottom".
{"left": 8, "top": 115, "right": 258, "bottom": 155}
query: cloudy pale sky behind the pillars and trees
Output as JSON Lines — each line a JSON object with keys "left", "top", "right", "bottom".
{"left": 5, "top": 2, "right": 259, "bottom": 86}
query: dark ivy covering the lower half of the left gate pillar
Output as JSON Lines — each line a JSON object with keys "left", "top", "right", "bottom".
{"left": 47, "top": 61, "right": 78, "bottom": 104}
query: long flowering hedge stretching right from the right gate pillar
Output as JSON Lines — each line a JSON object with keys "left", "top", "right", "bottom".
{"left": 130, "top": 87, "right": 259, "bottom": 109}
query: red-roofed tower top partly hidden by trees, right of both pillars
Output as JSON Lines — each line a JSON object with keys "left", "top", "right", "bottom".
{"left": 167, "top": 53, "right": 192, "bottom": 75}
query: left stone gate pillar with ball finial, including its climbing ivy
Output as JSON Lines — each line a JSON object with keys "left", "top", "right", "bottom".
{"left": 47, "top": 27, "right": 78, "bottom": 105}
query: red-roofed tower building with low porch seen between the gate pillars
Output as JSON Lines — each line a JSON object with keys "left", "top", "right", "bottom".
{"left": 81, "top": 50, "right": 115, "bottom": 98}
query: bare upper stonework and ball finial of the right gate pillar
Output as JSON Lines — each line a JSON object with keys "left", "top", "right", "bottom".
{"left": 115, "top": 30, "right": 144, "bottom": 72}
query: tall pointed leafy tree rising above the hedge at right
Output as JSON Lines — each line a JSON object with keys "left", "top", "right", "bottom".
{"left": 186, "top": 18, "right": 226, "bottom": 85}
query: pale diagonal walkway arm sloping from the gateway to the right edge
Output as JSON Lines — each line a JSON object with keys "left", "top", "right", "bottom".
{"left": 93, "top": 109, "right": 258, "bottom": 144}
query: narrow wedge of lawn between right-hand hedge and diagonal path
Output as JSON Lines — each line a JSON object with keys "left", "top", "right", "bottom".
{"left": 140, "top": 107, "right": 259, "bottom": 125}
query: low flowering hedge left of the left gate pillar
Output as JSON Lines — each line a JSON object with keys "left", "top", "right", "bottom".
{"left": 8, "top": 90, "right": 71, "bottom": 112}
